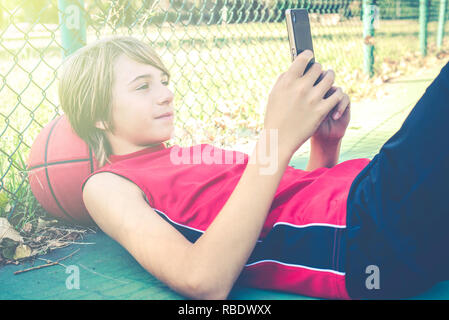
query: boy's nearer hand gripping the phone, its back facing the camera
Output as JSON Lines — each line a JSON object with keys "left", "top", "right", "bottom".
{"left": 264, "top": 50, "right": 343, "bottom": 155}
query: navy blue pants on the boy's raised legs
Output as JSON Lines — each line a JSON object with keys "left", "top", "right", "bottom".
{"left": 344, "top": 63, "right": 449, "bottom": 299}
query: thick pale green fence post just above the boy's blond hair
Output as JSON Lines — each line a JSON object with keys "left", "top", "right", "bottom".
{"left": 58, "top": 0, "right": 86, "bottom": 57}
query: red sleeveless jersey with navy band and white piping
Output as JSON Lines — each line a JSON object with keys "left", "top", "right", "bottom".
{"left": 83, "top": 144, "right": 370, "bottom": 299}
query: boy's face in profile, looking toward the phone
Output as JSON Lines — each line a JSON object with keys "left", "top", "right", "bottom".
{"left": 99, "top": 55, "right": 174, "bottom": 154}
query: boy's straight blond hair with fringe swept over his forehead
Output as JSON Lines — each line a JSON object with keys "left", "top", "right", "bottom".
{"left": 58, "top": 36, "right": 170, "bottom": 168}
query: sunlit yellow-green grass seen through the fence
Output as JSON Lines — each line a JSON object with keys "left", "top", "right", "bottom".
{"left": 0, "top": 20, "right": 449, "bottom": 262}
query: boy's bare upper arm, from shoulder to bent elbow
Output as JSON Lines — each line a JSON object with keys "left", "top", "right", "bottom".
{"left": 83, "top": 172, "right": 203, "bottom": 299}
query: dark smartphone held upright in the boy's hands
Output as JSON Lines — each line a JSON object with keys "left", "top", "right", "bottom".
{"left": 285, "top": 9, "right": 315, "bottom": 73}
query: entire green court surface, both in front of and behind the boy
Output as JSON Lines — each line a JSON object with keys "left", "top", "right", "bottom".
{"left": 0, "top": 66, "right": 449, "bottom": 300}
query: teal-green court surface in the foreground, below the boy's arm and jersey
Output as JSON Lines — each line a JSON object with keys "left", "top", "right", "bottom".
{"left": 0, "top": 228, "right": 449, "bottom": 300}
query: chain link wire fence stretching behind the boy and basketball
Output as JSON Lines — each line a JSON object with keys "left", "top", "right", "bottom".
{"left": 0, "top": 0, "right": 449, "bottom": 224}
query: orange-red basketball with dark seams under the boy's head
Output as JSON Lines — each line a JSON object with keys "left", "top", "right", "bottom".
{"left": 27, "top": 115, "right": 98, "bottom": 225}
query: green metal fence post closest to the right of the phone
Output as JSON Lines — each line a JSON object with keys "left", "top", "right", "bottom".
{"left": 362, "top": 0, "right": 375, "bottom": 78}
